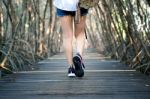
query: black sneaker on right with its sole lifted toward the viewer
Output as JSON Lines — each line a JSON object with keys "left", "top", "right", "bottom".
{"left": 73, "top": 53, "right": 85, "bottom": 77}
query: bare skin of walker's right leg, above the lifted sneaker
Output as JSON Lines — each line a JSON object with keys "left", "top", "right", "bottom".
{"left": 75, "top": 16, "right": 86, "bottom": 56}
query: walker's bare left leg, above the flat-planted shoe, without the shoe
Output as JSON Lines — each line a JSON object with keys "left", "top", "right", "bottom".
{"left": 60, "top": 16, "right": 73, "bottom": 66}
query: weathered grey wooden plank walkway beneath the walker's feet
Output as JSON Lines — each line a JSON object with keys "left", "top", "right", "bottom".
{"left": 0, "top": 49, "right": 150, "bottom": 99}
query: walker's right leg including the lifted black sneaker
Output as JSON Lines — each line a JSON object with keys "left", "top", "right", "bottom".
{"left": 73, "top": 16, "right": 86, "bottom": 77}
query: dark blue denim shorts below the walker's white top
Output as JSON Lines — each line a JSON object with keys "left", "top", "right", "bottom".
{"left": 56, "top": 8, "right": 88, "bottom": 17}
